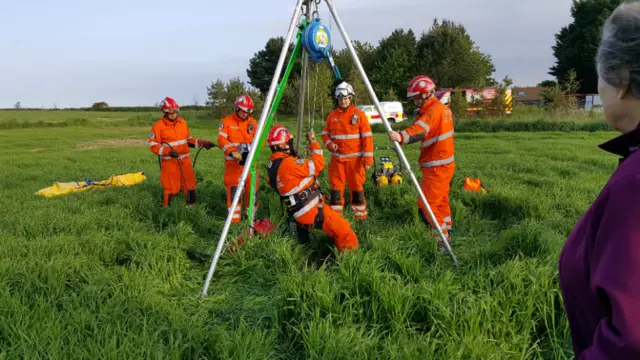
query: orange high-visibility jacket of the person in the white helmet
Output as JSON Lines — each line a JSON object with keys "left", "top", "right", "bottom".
{"left": 322, "top": 105, "right": 373, "bottom": 165}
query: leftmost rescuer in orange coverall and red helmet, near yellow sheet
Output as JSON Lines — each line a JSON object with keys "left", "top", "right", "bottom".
{"left": 149, "top": 97, "right": 214, "bottom": 207}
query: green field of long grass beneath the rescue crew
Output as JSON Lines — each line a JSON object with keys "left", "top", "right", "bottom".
{"left": 0, "top": 112, "right": 617, "bottom": 359}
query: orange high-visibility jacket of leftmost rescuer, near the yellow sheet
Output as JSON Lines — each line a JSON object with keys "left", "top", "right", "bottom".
{"left": 149, "top": 116, "right": 202, "bottom": 160}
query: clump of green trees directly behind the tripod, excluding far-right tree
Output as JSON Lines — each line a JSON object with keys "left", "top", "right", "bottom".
{"left": 207, "top": 19, "right": 499, "bottom": 116}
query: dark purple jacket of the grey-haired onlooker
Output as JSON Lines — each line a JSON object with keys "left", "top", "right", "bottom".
{"left": 559, "top": 127, "right": 640, "bottom": 360}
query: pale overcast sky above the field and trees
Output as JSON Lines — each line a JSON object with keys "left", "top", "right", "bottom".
{"left": 0, "top": 0, "right": 571, "bottom": 107}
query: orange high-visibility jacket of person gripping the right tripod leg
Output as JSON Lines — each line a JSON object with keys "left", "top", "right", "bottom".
{"left": 400, "top": 96, "right": 454, "bottom": 168}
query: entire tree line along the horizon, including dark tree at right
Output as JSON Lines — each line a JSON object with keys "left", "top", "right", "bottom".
{"left": 46, "top": 0, "right": 608, "bottom": 117}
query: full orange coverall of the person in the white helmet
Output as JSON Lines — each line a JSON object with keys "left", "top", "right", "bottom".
{"left": 322, "top": 104, "right": 373, "bottom": 220}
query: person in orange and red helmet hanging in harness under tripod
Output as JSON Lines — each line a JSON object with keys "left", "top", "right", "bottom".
{"left": 267, "top": 126, "right": 359, "bottom": 253}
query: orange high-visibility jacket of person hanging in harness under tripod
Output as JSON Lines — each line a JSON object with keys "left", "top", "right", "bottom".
{"left": 269, "top": 141, "right": 324, "bottom": 219}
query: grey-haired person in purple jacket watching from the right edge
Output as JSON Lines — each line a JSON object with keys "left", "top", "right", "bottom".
{"left": 559, "top": 1, "right": 640, "bottom": 360}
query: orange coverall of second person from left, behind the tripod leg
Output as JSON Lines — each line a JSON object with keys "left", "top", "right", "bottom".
{"left": 218, "top": 113, "right": 260, "bottom": 222}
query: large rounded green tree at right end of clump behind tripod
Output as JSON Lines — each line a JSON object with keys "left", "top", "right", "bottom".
{"left": 416, "top": 19, "right": 495, "bottom": 88}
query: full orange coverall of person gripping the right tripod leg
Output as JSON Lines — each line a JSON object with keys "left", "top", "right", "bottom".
{"left": 400, "top": 96, "right": 456, "bottom": 245}
